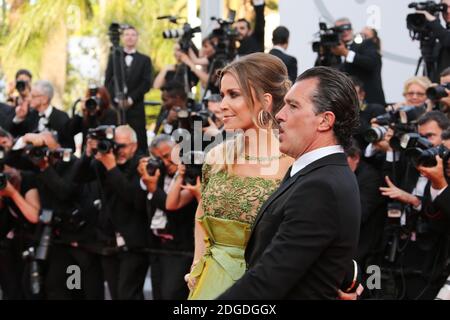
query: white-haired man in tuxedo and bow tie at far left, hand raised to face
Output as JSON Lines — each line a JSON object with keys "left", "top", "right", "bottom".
{"left": 10, "top": 80, "right": 75, "bottom": 149}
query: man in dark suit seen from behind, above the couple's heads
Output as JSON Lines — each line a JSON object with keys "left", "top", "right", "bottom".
{"left": 269, "top": 26, "right": 297, "bottom": 83}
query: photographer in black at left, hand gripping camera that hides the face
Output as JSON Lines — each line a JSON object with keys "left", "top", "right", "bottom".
{"left": 23, "top": 132, "right": 103, "bottom": 300}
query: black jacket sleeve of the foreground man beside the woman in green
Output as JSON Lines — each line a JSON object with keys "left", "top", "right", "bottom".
{"left": 219, "top": 180, "right": 338, "bottom": 300}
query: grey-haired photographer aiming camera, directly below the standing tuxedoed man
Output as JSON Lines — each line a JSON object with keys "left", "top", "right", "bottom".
{"left": 77, "top": 126, "right": 148, "bottom": 300}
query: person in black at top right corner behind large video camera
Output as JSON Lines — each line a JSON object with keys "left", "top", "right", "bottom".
{"left": 417, "top": 0, "right": 450, "bottom": 81}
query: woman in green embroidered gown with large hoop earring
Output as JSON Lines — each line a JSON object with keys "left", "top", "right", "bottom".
{"left": 185, "top": 53, "right": 292, "bottom": 300}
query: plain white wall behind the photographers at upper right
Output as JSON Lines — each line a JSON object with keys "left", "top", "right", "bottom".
{"left": 279, "top": 0, "right": 426, "bottom": 102}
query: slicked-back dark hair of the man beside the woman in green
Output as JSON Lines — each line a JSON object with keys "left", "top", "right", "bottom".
{"left": 296, "top": 67, "right": 359, "bottom": 148}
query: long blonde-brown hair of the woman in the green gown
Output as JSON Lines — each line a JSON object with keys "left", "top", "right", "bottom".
{"left": 207, "top": 53, "right": 292, "bottom": 172}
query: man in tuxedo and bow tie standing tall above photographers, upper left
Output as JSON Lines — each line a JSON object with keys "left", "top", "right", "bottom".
{"left": 105, "top": 26, "right": 152, "bottom": 154}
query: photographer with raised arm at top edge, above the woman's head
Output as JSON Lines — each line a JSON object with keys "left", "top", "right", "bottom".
{"left": 234, "top": 0, "right": 266, "bottom": 57}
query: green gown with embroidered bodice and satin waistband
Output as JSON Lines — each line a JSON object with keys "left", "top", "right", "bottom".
{"left": 189, "top": 164, "right": 280, "bottom": 300}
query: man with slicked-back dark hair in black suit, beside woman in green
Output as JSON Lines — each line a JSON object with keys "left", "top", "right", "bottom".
{"left": 219, "top": 67, "right": 361, "bottom": 299}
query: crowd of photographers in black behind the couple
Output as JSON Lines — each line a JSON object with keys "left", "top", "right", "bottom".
{"left": 0, "top": 0, "right": 450, "bottom": 299}
